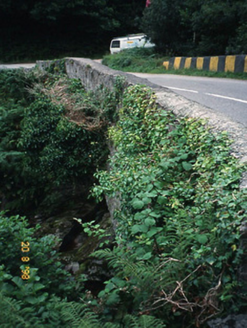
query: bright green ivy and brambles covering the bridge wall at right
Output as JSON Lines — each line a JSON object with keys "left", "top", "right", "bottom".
{"left": 93, "top": 86, "right": 247, "bottom": 328}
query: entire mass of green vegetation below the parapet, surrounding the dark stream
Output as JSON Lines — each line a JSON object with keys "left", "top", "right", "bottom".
{"left": 0, "top": 65, "right": 247, "bottom": 328}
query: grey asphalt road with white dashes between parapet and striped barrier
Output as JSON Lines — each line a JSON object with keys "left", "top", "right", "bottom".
{"left": 131, "top": 73, "right": 247, "bottom": 127}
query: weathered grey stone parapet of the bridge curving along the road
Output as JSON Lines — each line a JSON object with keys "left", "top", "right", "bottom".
{"left": 37, "top": 58, "right": 247, "bottom": 290}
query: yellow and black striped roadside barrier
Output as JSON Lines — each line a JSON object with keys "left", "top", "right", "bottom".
{"left": 163, "top": 55, "right": 247, "bottom": 73}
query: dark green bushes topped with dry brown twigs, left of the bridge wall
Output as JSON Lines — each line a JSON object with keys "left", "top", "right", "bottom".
{"left": 0, "top": 70, "right": 114, "bottom": 214}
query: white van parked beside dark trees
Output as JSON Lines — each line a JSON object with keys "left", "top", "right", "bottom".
{"left": 110, "top": 33, "right": 155, "bottom": 54}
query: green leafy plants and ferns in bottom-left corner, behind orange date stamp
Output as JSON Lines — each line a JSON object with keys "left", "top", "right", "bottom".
{"left": 0, "top": 213, "right": 83, "bottom": 328}
